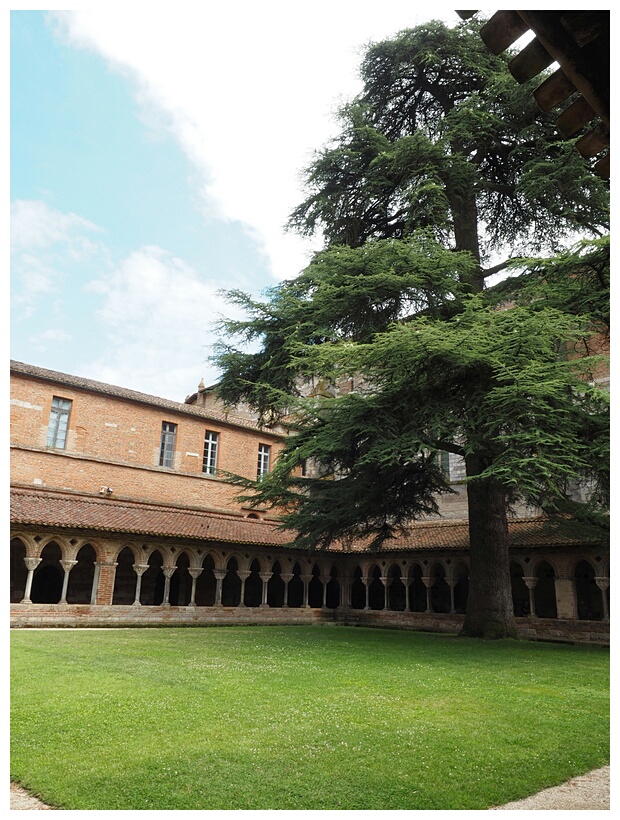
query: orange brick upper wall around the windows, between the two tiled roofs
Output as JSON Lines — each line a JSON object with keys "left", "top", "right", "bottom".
{"left": 11, "top": 373, "right": 282, "bottom": 509}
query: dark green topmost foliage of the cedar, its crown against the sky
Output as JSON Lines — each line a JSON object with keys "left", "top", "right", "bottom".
{"left": 291, "top": 22, "right": 609, "bottom": 262}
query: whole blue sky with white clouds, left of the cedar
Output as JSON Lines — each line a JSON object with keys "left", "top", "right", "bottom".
{"left": 10, "top": 0, "right": 458, "bottom": 401}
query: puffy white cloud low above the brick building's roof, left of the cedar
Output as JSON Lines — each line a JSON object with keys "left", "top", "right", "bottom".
{"left": 83, "top": 246, "right": 242, "bottom": 401}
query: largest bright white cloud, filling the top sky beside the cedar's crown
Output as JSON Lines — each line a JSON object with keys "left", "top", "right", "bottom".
{"left": 48, "top": 0, "right": 458, "bottom": 278}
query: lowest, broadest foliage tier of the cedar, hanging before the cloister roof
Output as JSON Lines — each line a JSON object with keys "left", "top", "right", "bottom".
{"left": 225, "top": 297, "right": 609, "bottom": 546}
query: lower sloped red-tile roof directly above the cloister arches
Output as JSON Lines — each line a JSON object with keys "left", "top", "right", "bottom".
{"left": 10, "top": 487, "right": 593, "bottom": 553}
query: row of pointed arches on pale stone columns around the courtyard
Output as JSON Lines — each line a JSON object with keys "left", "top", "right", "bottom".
{"left": 10, "top": 531, "right": 609, "bottom": 621}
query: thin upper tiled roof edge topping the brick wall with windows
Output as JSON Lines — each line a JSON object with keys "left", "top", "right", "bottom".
{"left": 10, "top": 359, "right": 284, "bottom": 439}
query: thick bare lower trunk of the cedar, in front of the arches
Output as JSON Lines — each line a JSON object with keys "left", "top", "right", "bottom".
{"left": 461, "top": 456, "right": 517, "bottom": 638}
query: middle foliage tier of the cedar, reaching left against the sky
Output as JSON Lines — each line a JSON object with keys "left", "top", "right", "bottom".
{"left": 214, "top": 232, "right": 473, "bottom": 420}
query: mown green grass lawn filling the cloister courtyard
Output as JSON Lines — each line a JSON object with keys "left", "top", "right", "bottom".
{"left": 11, "top": 626, "right": 609, "bottom": 810}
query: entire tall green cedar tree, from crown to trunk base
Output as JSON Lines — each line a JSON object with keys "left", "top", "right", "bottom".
{"left": 216, "top": 17, "right": 608, "bottom": 637}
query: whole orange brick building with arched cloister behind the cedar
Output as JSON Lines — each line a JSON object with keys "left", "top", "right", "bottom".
{"left": 10, "top": 362, "right": 609, "bottom": 642}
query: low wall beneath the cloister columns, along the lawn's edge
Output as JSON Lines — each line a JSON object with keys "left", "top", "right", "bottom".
{"left": 11, "top": 604, "right": 609, "bottom": 645}
